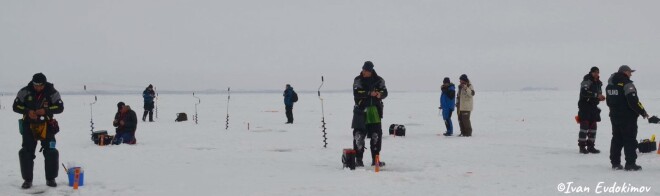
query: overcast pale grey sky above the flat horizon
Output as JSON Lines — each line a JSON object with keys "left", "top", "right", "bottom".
{"left": 0, "top": 0, "right": 660, "bottom": 92}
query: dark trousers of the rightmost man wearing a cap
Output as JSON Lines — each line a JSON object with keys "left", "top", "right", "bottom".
{"left": 610, "top": 118, "right": 637, "bottom": 165}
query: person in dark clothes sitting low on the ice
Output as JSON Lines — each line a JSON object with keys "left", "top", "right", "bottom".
{"left": 112, "top": 102, "right": 137, "bottom": 145}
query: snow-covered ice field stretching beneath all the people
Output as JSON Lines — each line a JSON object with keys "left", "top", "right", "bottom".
{"left": 0, "top": 89, "right": 660, "bottom": 195}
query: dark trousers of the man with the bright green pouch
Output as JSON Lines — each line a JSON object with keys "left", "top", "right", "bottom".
{"left": 353, "top": 123, "right": 383, "bottom": 164}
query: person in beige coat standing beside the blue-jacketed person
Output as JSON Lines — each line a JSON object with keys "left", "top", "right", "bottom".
{"left": 456, "top": 74, "right": 474, "bottom": 137}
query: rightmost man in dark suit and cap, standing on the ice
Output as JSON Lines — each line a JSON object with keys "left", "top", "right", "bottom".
{"left": 606, "top": 65, "right": 649, "bottom": 171}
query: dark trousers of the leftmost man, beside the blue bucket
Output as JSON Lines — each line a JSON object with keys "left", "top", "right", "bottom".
{"left": 18, "top": 123, "right": 60, "bottom": 181}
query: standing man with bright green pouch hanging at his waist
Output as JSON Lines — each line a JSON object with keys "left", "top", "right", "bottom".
{"left": 352, "top": 61, "right": 387, "bottom": 167}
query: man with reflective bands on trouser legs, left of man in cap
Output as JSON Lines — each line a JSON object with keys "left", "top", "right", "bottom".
{"left": 578, "top": 67, "right": 605, "bottom": 154}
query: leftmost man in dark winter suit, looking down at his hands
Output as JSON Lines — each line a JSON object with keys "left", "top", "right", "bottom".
{"left": 12, "top": 73, "right": 64, "bottom": 189}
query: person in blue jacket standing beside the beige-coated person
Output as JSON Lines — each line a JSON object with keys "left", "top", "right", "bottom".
{"left": 440, "top": 77, "right": 456, "bottom": 136}
